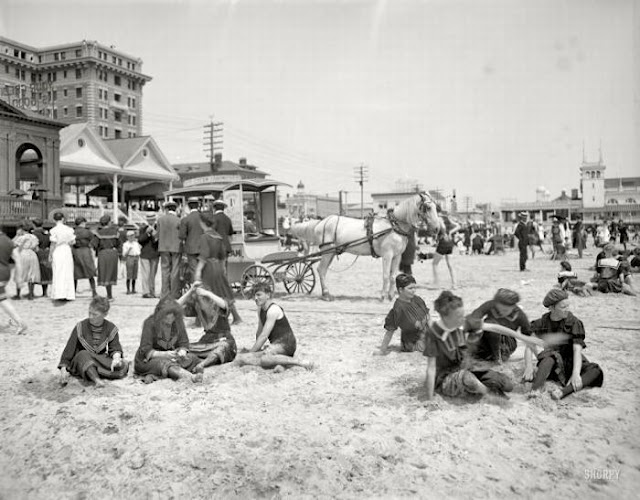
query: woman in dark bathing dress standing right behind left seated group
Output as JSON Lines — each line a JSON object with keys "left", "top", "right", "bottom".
{"left": 194, "top": 212, "right": 242, "bottom": 324}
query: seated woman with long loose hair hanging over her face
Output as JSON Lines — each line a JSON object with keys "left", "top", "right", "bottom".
{"left": 134, "top": 296, "right": 203, "bottom": 383}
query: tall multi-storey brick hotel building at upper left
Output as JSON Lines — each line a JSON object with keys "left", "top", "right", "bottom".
{"left": 0, "top": 37, "right": 151, "bottom": 139}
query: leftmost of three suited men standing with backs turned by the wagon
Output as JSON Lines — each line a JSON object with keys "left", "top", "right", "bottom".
{"left": 157, "top": 201, "right": 181, "bottom": 299}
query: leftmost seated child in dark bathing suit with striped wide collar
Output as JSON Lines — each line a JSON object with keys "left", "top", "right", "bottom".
{"left": 58, "top": 296, "right": 129, "bottom": 387}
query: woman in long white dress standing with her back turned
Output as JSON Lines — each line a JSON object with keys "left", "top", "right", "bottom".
{"left": 49, "top": 212, "right": 76, "bottom": 305}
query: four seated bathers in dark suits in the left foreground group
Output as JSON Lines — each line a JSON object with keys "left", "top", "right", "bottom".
{"left": 58, "top": 283, "right": 313, "bottom": 387}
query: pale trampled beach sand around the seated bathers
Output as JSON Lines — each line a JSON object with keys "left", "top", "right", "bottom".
{"left": 0, "top": 247, "right": 640, "bottom": 499}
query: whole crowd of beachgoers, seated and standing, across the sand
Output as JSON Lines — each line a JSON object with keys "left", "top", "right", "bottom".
{"left": 0, "top": 198, "right": 640, "bottom": 400}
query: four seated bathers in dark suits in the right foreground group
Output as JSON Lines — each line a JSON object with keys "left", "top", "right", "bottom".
{"left": 378, "top": 274, "right": 603, "bottom": 400}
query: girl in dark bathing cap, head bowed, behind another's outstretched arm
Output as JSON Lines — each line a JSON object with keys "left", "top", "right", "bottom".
{"left": 469, "top": 288, "right": 531, "bottom": 363}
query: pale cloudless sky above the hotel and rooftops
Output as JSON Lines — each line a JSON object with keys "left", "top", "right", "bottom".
{"left": 0, "top": 0, "right": 640, "bottom": 203}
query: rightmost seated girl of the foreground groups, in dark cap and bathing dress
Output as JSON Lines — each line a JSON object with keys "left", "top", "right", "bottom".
{"left": 525, "top": 288, "right": 604, "bottom": 399}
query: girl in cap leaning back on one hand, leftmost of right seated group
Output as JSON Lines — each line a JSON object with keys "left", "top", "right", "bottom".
{"left": 376, "top": 273, "right": 429, "bottom": 355}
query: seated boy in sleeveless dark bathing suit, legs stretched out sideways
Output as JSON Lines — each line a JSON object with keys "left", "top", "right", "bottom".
{"left": 236, "top": 283, "right": 313, "bottom": 370}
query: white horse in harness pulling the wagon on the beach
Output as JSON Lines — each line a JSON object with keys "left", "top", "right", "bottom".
{"left": 304, "top": 193, "right": 441, "bottom": 300}
